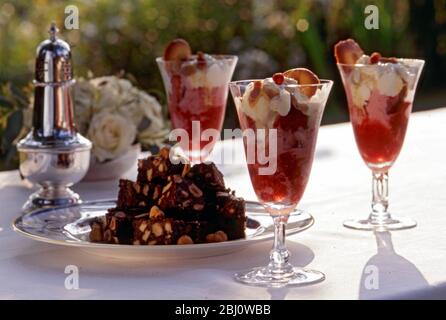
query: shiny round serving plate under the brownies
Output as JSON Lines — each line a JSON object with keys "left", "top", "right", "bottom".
{"left": 13, "top": 200, "right": 314, "bottom": 259}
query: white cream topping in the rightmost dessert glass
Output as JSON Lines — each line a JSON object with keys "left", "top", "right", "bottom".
{"left": 348, "top": 55, "right": 416, "bottom": 108}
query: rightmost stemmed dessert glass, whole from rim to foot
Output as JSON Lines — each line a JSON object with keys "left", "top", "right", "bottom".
{"left": 338, "top": 40, "right": 424, "bottom": 230}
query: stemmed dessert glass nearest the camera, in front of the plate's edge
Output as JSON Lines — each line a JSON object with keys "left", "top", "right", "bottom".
{"left": 229, "top": 72, "right": 332, "bottom": 287}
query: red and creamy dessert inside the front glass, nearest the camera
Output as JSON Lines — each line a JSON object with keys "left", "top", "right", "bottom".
{"left": 235, "top": 69, "right": 328, "bottom": 207}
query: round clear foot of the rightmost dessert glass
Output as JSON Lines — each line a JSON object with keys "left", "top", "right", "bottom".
{"left": 344, "top": 216, "right": 417, "bottom": 231}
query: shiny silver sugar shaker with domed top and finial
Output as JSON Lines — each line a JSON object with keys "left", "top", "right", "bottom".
{"left": 17, "top": 23, "right": 91, "bottom": 212}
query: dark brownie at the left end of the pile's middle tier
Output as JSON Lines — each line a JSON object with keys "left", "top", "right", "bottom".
{"left": 117, "top": 179, "right": 162, "bottom": 209}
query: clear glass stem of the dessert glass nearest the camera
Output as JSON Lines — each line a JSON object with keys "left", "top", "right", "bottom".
{"left": 269, "top": 215, "right": 292, "bottom": 274}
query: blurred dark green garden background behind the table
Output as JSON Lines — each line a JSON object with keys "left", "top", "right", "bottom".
{"left": 0, "top": 0, "right": 446, "bottom": 170}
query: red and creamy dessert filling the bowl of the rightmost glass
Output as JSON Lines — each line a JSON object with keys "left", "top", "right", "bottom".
{"left": 337, "top": 42, "right": 420, "bottom": 171}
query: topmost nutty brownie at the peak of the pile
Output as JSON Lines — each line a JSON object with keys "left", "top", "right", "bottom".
{"left": 137, "top": 148, "right": 190, "bottom": 184}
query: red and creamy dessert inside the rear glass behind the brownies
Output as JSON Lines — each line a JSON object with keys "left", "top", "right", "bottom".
{"left": 162, "top": 54, "right": 236, "bottom": 151}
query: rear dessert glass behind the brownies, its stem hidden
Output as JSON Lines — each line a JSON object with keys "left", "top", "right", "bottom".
{"left": 156, "top": 42, "right": 237, "bottom": 163}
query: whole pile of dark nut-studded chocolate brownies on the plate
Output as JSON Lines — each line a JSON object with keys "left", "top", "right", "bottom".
{"left": 90, "top": 148, "right": 246, "bottom": 245}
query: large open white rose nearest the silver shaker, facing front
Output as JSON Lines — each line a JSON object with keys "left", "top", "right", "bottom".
{"left": 87, "top": 112, "right": 136, "bottom": 162}
